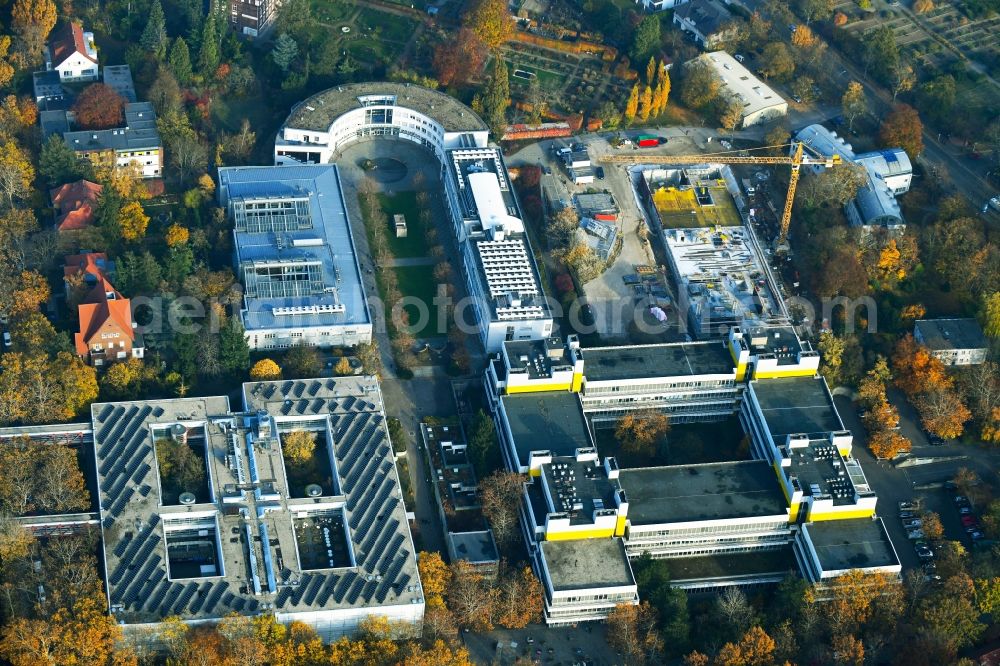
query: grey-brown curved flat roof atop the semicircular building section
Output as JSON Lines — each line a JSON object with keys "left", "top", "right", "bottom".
{"left": 284, "top": 81, "right": 488, "bottom": 132}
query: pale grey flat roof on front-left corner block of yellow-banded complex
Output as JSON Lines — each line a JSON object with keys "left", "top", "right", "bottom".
{"left": 541, "top": 538, "right": 635, "bottom": 591}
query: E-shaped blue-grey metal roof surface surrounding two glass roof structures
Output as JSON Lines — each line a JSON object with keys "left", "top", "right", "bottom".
{"left": 219, "top": 164, "right": 371, "bottom": 331}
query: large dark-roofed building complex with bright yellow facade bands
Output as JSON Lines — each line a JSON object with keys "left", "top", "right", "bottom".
{"left": 484, "top": 325, "right": 900, "bottom": 624}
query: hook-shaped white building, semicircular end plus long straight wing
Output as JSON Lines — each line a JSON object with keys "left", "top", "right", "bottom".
{"left": 274, "top": 82, "right": 553, "bottom": 353}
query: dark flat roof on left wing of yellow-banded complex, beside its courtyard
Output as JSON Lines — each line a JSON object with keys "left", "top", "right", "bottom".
{"left": 500, "top": 393, "right": 594, "bottom": 464}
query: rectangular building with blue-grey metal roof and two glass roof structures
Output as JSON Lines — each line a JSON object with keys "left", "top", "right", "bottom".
{"left": 218, "top": 165, "right": 372, "bottom": 349}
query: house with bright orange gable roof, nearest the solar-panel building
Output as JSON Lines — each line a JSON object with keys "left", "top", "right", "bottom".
{"left": 75, "top": 277, "right": 144, "bottom": 366}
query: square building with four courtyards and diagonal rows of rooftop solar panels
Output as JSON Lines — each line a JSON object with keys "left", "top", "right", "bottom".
{"left": 84, "top": 377, "right": 424, "bottom": 640}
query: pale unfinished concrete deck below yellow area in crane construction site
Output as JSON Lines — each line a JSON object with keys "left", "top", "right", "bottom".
{"left": 663, "top": 226, "right": 784, "bottom": 323}
